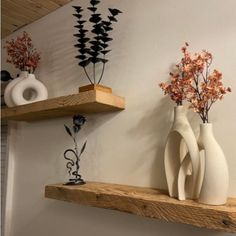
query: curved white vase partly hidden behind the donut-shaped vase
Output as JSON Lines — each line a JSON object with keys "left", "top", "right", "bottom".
{"left": 4, "top": 71, "right": 28, "bottom": 107}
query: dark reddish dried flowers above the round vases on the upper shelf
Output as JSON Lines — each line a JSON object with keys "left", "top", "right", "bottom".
{"left": 4, "top": 31, "right": 40, "bottom": 73}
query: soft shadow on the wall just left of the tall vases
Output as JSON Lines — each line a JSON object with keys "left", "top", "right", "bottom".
{"left": 129, "top": 97, "right": 173, "bottom": 189}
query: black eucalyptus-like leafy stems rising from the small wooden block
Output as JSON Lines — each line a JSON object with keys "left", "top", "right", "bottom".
{"left": 73, "top": 0, "right": 122, "bottom": 84}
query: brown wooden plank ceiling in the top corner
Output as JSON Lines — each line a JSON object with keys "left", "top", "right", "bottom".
{"left": 1, "top": 0, "right": 71, "bottom": 38}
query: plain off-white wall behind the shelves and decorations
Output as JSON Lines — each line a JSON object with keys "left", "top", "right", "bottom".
{"left": 2, "top": 0, "right": 236, "bottom": 236}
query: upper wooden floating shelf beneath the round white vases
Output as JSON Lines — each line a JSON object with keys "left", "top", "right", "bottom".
{"left": 1, "top": 90, "right": 125, "bottom": 121}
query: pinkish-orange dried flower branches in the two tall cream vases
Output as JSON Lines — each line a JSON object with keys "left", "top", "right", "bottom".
{"left": 159, "top": 43, "right": 231, "bottom": 123}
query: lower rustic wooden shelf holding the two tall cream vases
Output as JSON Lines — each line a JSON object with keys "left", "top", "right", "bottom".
{"left": 45, "top": 182, "right": 236, "bottom": 232}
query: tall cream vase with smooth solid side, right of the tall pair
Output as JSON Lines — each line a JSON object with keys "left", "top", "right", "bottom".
{"left": 198, "top": 123, "right": 229, "bottom": 205}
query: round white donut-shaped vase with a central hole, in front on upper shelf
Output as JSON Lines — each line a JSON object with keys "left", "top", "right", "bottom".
{"left": 11, "top": 74, "right": 48, "bottom": 105}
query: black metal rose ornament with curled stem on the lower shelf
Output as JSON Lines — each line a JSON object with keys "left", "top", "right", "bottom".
{"left": 64, "top": 115, "right": 87, "bottom": 185}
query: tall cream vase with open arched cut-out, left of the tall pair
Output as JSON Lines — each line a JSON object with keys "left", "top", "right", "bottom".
{"left": 164, "top": 106, "right": 201, "bottom": 200}
